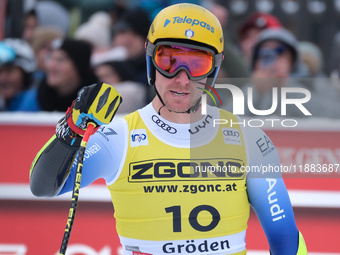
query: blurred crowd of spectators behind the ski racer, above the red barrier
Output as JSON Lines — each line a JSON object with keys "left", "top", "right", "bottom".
{"left": 0, "top": 0, "right": 340, "bottom": 118}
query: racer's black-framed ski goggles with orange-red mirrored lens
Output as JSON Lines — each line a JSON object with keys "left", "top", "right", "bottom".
{"left": 146, "top": 42, "right": 223, "bottom": 80}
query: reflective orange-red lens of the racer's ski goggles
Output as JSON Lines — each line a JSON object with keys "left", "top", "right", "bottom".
{"left": 154, "top": 45, "right": 213, "bottom": 77}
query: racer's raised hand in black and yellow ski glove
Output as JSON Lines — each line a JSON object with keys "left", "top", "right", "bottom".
{"left": 66, "top": 83, "right": 122, "bottom": 136}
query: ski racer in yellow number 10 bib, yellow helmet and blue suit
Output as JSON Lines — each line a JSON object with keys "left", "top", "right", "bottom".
{"left": 30, "top": 4, "right": 307, "bottom": 255}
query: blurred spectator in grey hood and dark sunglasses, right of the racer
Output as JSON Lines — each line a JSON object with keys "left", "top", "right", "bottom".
{"left": 234, "top": 28, "right": 332, "bottom": 117}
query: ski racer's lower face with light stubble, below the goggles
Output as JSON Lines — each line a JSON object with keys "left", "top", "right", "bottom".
{"left": 155, "top": 70, "right": 207, "bottom": 113}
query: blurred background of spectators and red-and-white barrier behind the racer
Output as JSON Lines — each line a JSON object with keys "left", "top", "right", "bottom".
{"left": 0, "top": 0, "right": 340, "bottom": 255}
